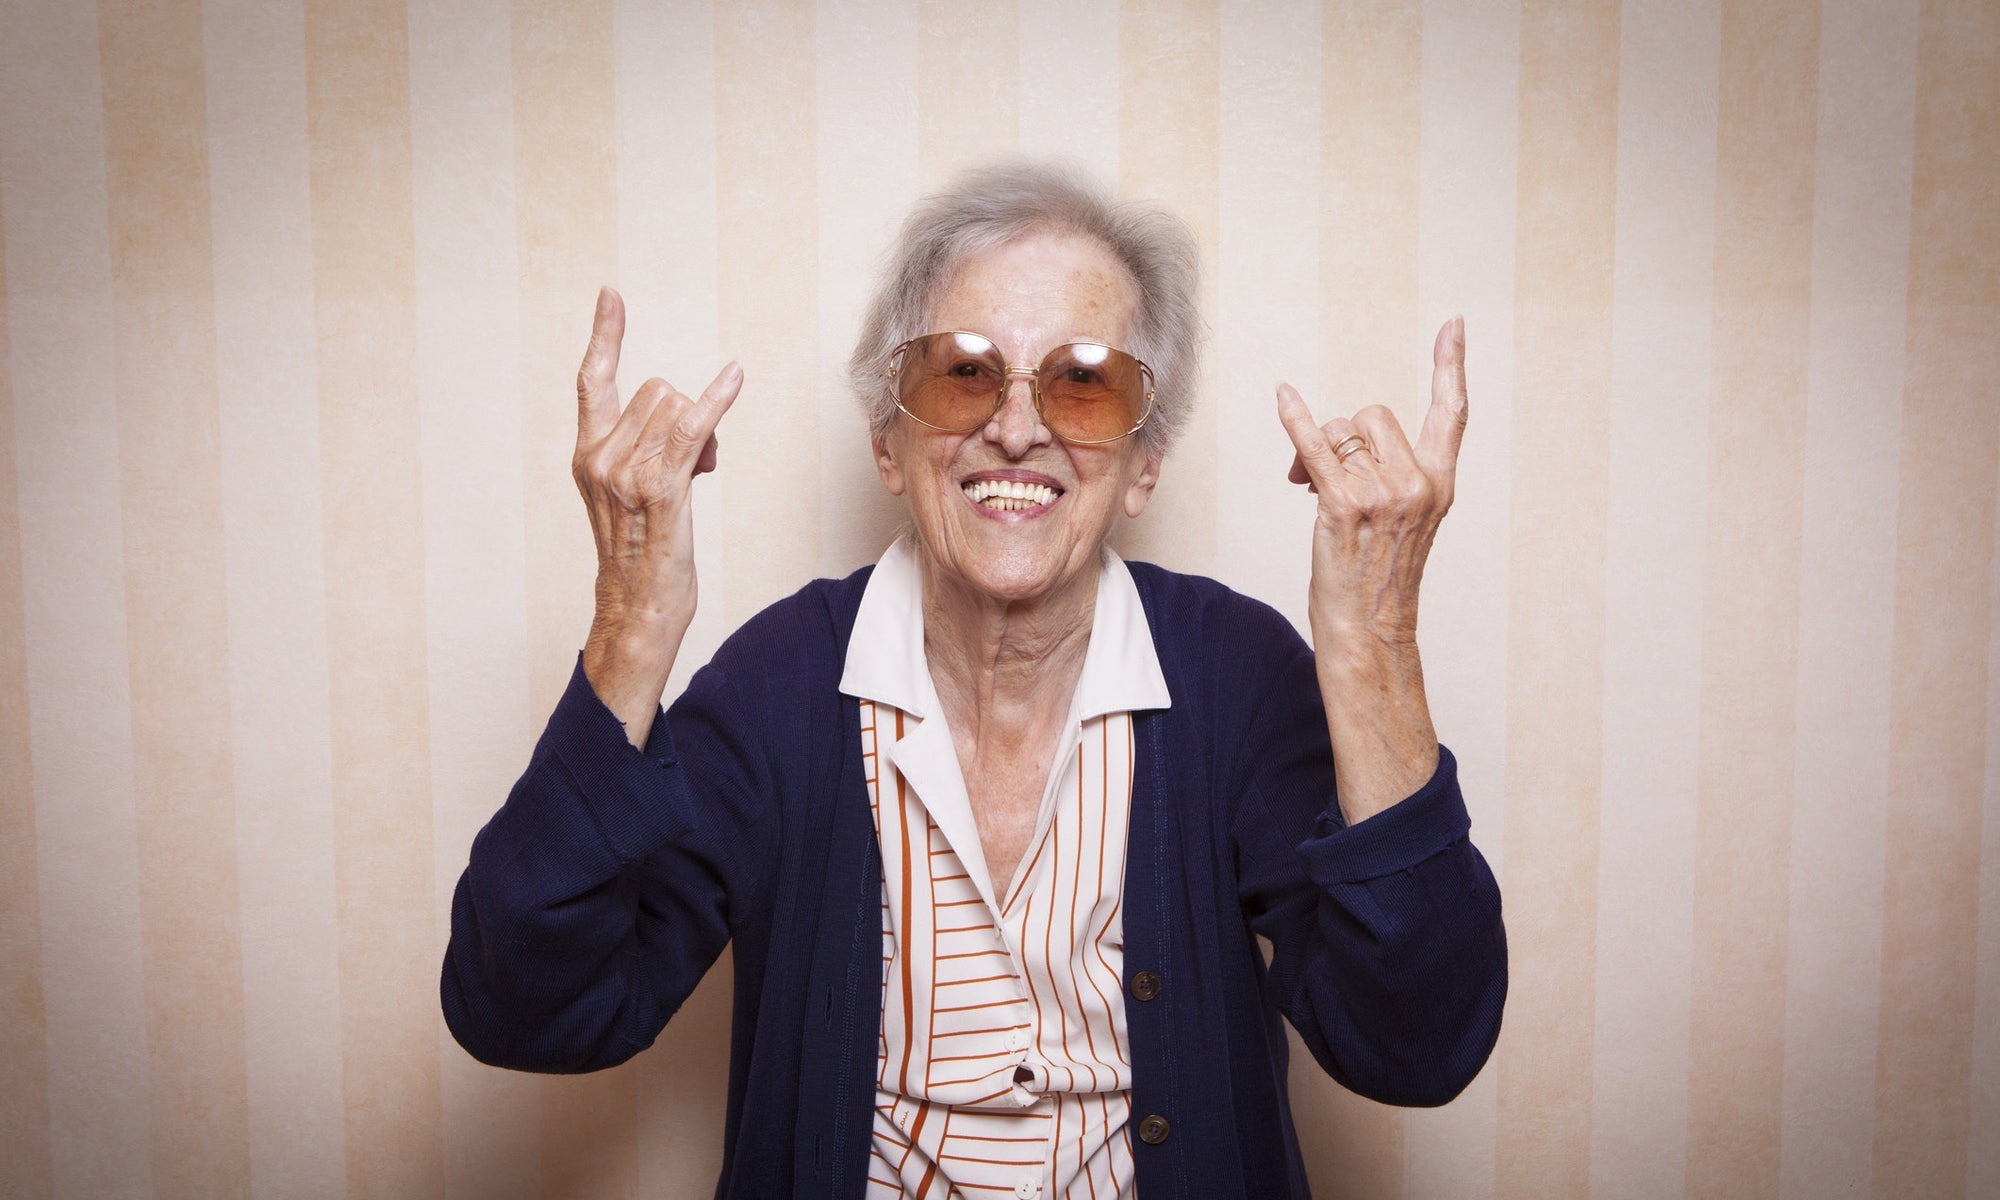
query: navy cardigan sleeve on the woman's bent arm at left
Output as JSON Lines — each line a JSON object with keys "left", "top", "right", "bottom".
{"left": 440, "top": 662, "right": 764, "bottom": 1072}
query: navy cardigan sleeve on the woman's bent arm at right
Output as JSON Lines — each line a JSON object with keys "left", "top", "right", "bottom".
{"left": 1234, "top": 618, "right": 1506, "bottom": 1106}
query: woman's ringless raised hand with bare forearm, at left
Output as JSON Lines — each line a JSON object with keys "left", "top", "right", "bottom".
{"left": 572, "top": 288, "right": 744, "bottom": 746}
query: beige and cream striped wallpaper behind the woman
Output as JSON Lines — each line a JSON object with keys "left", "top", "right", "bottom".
{"left": 0, "top": 0, "right": 2000, "bottom": 1200}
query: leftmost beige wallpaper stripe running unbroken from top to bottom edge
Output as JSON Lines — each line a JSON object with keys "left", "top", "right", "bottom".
{"left": 98, "top": 0, "right": 250, "bottom": 1198}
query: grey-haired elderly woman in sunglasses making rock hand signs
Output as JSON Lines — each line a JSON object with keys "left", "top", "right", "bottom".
{"left": 444, "top": 164, "right": 1506, "bottom": 1200}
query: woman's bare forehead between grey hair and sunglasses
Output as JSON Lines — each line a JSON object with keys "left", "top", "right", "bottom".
{"left": 932, "top": 234, "right": 1138, "bottom": 358}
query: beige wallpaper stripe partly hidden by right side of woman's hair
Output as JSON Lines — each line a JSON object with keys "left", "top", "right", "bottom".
{"left": 1116, "top": 0, "right": 1234, "bottom": 574}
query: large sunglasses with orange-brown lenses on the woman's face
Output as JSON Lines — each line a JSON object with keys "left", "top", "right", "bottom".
{"left": 888, "top": 332, "right": 1152, "bottom": 446}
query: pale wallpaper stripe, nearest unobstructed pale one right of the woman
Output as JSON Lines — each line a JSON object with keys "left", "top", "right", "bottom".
{"left": 1590, "top": 0, "right": 1722, "bottom": 1196}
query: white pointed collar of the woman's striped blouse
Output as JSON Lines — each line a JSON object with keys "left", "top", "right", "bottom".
{"left": 840, "top": 534, "right": 1172, "bottom": 722}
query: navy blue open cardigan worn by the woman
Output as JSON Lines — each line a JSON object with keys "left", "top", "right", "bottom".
{"left": 442, "top": 564, "right": 1506, "bottom": 1200}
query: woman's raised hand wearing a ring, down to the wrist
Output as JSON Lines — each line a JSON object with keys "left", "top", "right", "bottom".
{"left": 1278, "top": 318, "right": 1466, "bottom": 646}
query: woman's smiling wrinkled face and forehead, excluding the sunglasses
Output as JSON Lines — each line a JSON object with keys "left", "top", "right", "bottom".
{"left": 874, "top": 234, "right": 1160, "bottom": 602}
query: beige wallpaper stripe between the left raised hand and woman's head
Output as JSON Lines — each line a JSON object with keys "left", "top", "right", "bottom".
{"left": 716, "top": 0, "right": 820, "bottom": 628}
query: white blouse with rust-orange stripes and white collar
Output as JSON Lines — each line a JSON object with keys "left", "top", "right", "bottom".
{"left": 842, "top": 540, "right": 1168, "bottom": 1200}
